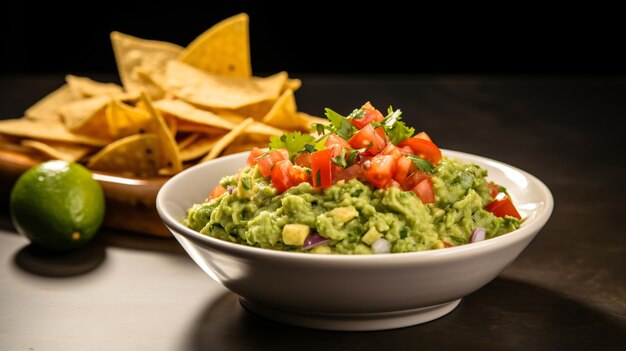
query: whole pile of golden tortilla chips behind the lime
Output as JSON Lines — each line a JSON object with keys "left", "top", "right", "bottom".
{"left": 0, "top": 14, "right": 319, "bottom": 177}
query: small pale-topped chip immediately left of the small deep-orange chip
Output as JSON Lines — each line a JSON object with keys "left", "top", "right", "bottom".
{"left": 60, "top": 96, "right": 111, "bottom": 139}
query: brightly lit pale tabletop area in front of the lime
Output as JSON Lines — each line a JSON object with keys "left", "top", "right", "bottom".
{"left": 0, "top": 230, "right": 234, "bottom": 350}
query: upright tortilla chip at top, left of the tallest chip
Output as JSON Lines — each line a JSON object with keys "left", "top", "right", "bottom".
{"left": 111, "top": 32, "right": 182, "bottom": 96}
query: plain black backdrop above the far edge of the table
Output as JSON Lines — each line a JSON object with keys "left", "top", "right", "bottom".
{"left": 0, "top": 1, "right": 626, "bottom": 75}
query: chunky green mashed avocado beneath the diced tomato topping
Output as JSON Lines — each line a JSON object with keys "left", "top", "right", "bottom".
{"left": 185, "top": 158, "right": 520, "bottom": 254}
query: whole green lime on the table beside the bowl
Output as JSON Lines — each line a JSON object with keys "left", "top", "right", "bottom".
{"left": 11, "top": 161, "right": 104, "bottom": 250}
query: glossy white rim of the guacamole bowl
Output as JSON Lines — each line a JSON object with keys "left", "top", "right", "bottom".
{"left": 156, "top": 149, "right": 554, "bottom": 265}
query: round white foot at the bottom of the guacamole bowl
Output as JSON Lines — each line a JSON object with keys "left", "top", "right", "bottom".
{"left": 239, "top": 298, "right": 461, "bottom": 331}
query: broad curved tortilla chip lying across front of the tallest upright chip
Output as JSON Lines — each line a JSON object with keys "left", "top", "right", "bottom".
{"left": 164, "top": 61, "right": 287, "bottom": 109}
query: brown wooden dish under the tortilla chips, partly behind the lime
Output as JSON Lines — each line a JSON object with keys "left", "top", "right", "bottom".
{"left": 0, "top": 149, "right": 171, "bottom": 236}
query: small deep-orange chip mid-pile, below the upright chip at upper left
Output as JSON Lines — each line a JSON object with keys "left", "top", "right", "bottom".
{"left": 106, "top": 99, "right": 150, "bottom": 139}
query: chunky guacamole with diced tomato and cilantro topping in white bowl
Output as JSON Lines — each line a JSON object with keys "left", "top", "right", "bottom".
{"left": 185, "top": 105, "right": 520, "bottom": 254}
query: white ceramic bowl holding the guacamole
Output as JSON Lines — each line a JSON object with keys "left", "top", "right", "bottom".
{"left": 157, "top": 150, "right": 553, "bottom": 330}
